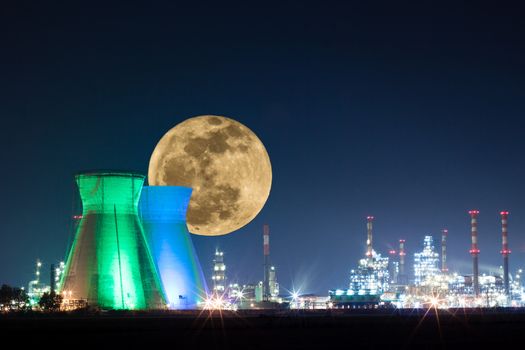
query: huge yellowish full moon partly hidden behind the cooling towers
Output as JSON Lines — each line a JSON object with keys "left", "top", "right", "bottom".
{"left": 148, "top": 115, "right": 272, "bottom": 236}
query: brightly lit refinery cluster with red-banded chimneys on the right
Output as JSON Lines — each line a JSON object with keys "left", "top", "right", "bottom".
{"left": 328, "top": 210, "right": 525, "bottom": 309}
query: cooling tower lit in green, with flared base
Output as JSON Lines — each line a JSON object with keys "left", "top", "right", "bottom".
{"left": 61, "top": 172, "right": 166, "bottom": 309}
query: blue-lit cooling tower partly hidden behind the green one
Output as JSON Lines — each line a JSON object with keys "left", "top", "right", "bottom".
{"left": 139, "top": 186, "right": 208, "bottom": 309}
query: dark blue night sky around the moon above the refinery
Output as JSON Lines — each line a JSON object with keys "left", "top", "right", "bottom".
{"left": 0, "top": 1, "right": 525, "bottom": 295}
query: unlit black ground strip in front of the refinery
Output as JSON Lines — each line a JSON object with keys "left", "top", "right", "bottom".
{"left": 0, "top": 309, "right": 525, "bottom": 350}
